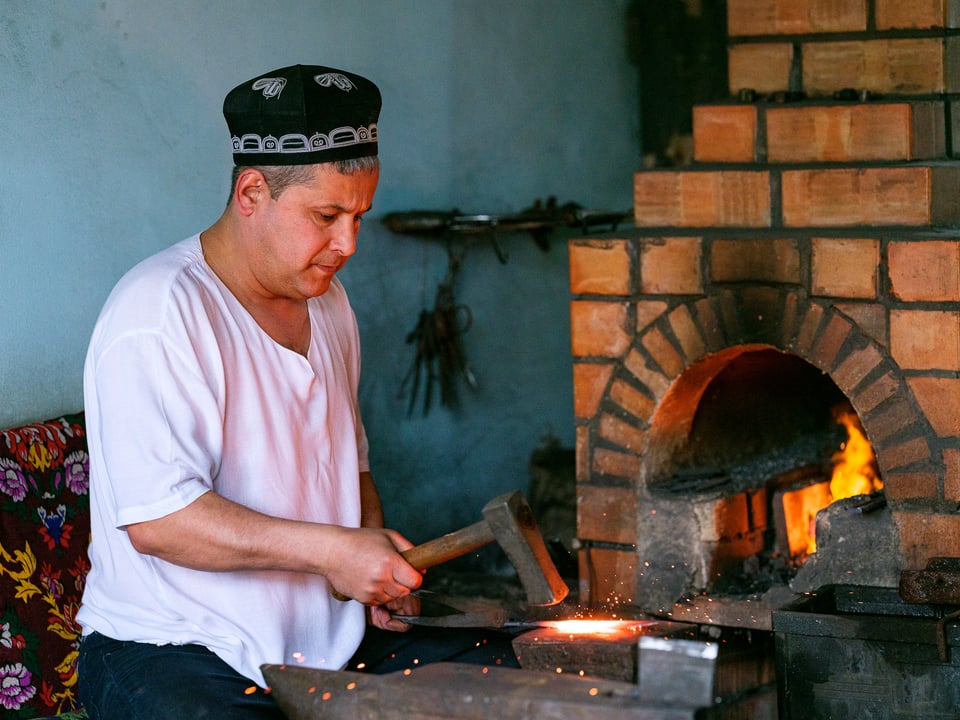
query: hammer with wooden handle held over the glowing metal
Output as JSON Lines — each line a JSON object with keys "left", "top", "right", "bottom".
{"left": 334, "top": 490, "right": 569, "bottom": 605}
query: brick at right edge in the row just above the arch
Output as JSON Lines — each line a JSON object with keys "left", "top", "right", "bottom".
{"left": 887, "top": 240, "right": 960, "bottom": 302}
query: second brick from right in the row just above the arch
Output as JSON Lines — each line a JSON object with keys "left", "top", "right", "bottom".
{"left": 810, "top": 238, "right": 880, "bottom": 298}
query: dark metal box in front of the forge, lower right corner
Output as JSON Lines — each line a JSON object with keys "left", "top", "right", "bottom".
{"left": 773, "top": 586, "right": 960, "bottom": 720}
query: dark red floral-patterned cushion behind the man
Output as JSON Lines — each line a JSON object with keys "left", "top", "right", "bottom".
{"left": 0, "top": 413, "right": 90, "bottom": 718}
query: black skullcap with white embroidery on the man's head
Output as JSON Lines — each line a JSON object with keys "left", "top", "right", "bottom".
{"left": 223, "top": 65, "right": 380, "bottom": 165}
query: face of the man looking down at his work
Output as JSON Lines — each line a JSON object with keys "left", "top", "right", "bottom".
{"left": 248, "top": 164, "right": 380, "bottom": 300}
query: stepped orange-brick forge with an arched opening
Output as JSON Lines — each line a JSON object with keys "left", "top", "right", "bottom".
{"left": 569, "top": 0, "right": 960, "bottom": 627}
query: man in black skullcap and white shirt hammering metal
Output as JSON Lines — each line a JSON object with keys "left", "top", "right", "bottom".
{"left": 78, "top": 65, "right": 421, "bottom": 720}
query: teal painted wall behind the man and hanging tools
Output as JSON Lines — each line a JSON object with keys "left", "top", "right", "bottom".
{"left": 0, "top": 0, "right": 640, "bottom": 542}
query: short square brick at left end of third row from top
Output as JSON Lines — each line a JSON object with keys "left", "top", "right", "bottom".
{"left": 693, "top": 105, "right": 757, "bottom": 162}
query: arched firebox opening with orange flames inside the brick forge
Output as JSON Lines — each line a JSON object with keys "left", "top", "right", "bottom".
{"left": 641, "top": 346, "right": 881, "bottom": 595}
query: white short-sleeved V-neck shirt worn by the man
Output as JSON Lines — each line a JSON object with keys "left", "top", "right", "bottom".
{"left": 77, "top": 235, "right": 368, "bottom": 684}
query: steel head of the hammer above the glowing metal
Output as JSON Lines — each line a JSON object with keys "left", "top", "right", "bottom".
{"left": 483, "top": 490, "right": 570, "bottom": 605}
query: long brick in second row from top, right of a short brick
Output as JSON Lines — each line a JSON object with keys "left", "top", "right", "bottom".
{"left": 801, "top": 37, "right": 956, "bottom": 95}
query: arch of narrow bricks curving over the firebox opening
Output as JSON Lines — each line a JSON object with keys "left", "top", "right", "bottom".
{"left": 590, "top": 286, "right": 946, "bottom": 504}
